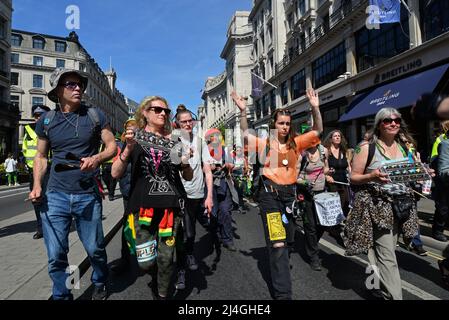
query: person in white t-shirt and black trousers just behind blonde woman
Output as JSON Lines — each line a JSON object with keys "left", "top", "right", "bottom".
{"left": 175, "top": 105, "right": 213, "bottom": 290}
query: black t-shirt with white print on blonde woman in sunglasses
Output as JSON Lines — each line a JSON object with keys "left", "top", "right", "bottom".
{"left": 127, "top": 130, "right": 187, "bottom": 213}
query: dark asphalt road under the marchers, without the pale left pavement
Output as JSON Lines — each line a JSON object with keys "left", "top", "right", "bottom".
{"left": 74, "top": 202, "right": 449, "bottom": 300}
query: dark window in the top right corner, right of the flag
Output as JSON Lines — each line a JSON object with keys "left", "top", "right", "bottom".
{"left": 420, "top": 0, "right": 449, "bottom": 41}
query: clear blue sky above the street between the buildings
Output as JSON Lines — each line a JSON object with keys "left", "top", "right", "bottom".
{"left": 12, "top": 0, "right": 252, "bottom": 112}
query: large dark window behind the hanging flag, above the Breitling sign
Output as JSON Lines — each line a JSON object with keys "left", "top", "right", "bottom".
{"left": 355, "top": 10, "right": 410, "bottom": 72}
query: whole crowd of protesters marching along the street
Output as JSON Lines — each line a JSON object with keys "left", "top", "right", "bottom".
{"left": 20, "top": 68, "right": 449, "bottom": 300}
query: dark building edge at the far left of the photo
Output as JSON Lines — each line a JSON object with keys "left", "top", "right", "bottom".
{"left": 0, "top": 0, "right": 20, "bottom": 163}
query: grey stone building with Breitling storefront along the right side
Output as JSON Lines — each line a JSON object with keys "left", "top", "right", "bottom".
{"left": 251, "top": 0, "right": 449, "bottom": 160}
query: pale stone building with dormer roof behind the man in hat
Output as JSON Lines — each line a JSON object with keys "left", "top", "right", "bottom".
{"left": 10, "top": 30, "right": 128, "bottom": 143}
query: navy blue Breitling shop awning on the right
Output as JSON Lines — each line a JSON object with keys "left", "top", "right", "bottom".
{"left": 339, "top": 64, "right": 449, "bottom": 122}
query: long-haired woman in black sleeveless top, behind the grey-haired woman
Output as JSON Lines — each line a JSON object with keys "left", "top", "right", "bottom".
{"left": 323, "top": 130, "right": 351, "bottom": 216}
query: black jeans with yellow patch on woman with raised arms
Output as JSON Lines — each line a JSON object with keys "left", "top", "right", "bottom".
{"left": 259, "top": 182, "right": 295, "bottom": 300}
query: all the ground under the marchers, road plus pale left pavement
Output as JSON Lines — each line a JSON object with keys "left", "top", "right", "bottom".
{"left": 0, "top": 182, "right": 449, "bottom": 300}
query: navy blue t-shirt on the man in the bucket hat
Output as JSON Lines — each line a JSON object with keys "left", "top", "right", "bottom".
{"left": 35, "top": 105, "right": 109, "bottom": 194}
